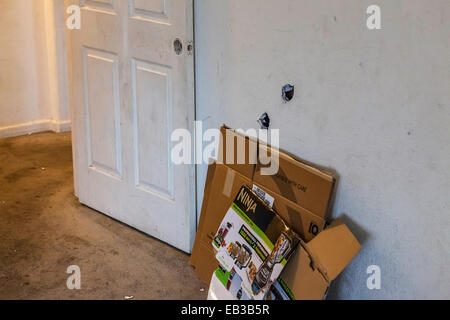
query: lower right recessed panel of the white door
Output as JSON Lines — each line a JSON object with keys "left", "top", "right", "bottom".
{"left": 133, "top": 60, "right": 174, "bottom": 200}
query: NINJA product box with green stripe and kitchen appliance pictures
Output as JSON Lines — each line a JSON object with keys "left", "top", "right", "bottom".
{"left": 212, "top": 186, "right": 299, "bottom": 300}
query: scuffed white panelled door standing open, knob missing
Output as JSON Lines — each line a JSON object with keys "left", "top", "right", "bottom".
{"left": 71, "top": 0, "right": 196, "bottom": 252}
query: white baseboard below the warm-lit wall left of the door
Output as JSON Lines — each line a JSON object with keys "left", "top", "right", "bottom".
{"left": 0, "top": 119, "right": 72, "bottom": 138}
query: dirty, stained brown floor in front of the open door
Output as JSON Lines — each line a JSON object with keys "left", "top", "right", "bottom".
{"left": 0, "top": 133, "right": 207, "bottom": 299}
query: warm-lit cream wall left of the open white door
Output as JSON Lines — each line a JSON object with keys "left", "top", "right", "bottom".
{"left": 0, "top": 0, "right": 70, "bottom": 137}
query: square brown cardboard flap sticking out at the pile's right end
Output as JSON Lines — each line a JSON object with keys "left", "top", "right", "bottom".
{"left": 306, "top": 219, "right": 361, "bottom": 282}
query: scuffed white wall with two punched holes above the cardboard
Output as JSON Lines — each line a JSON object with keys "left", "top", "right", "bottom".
{"left": 195, "top": 0, "right": 450, "bottom": 299}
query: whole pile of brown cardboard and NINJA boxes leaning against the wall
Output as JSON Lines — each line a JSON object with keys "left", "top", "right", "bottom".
{"left": 190, "top": 126, "right": 361, "bottom": 300}
